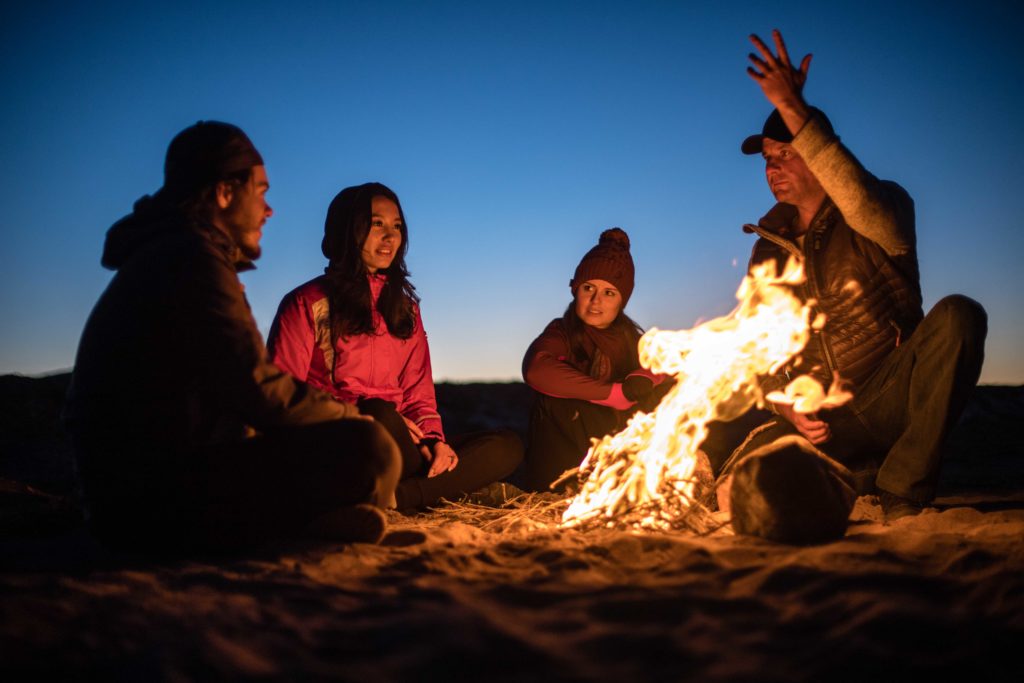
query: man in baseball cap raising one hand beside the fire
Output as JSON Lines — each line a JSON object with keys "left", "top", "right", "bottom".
{"left": 723, "top": 31, "right": 986, "bottom": 532}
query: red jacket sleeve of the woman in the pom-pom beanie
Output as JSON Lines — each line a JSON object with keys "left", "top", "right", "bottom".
{"left": 522, "top": 318, "right": 633, "bottom": 411}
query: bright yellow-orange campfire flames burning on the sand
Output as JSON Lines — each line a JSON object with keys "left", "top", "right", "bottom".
{"left": 562, "top": 259, "right": 844, "bottom": 529}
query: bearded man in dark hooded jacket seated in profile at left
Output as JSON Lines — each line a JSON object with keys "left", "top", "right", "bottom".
{"left": 65, "top": 121, "right": 399, "bottom": 552}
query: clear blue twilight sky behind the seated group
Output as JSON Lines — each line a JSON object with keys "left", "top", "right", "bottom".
{"left": 0, "top": 0, "right": 1024, "bottom": 383}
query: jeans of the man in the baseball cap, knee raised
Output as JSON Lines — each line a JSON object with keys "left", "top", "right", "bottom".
{"left": 722, "top": 295, "right": 987, "bottom": 503}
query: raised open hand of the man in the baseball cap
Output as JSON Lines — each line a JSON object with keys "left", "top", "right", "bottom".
{"left": 746, "top": 29, "right": 812, "bottom": 135}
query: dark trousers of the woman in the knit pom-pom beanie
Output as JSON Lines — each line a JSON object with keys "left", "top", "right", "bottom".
{"left": 521, "top": 393, "right": 631, "bottom": 492}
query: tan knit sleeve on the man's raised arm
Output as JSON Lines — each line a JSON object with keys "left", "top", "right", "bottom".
{"left": 793, "top": 117, "right": 916, "bottom": 256}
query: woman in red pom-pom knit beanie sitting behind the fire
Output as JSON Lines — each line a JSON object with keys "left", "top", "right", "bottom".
{"left": 521, "top": 227, "right": 662, "bottom": 490}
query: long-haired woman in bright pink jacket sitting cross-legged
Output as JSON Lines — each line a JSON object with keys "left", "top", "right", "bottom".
{"left": 267, "top": 182, "right": 522, "bottom": 510}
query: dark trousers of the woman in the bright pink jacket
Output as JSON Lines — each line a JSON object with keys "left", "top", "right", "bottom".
{"left": 358, "top": 398, "right": 522, "bottom": 511}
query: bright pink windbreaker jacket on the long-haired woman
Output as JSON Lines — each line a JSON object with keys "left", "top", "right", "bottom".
{"left": 267, "top": 274, "right": 444, "bottom": 440}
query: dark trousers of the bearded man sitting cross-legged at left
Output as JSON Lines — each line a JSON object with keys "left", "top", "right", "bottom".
{"left": 76, "top": 420, "right": 399, "bottom": 552}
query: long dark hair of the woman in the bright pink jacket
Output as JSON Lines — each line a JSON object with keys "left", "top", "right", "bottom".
{"left": 321, "top": 182, "right": 420, "bottom": 342}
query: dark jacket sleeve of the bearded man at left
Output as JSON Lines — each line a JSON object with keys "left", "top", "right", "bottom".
{"left": 188, "top": 246, "right": 358, "bottom": 431}
